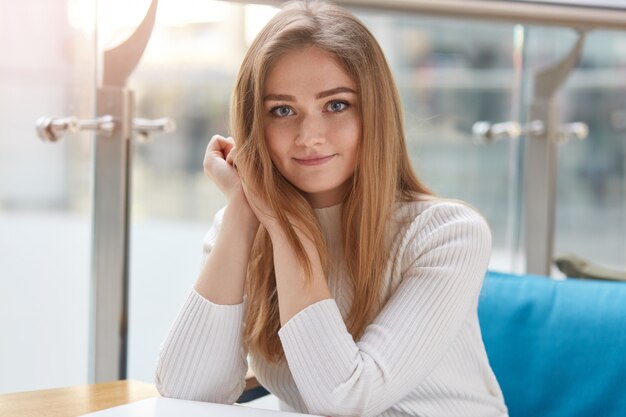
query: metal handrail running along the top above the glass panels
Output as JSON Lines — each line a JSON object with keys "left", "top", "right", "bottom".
{"left": 234, "top": 0, "right": 626, "bottom": 30}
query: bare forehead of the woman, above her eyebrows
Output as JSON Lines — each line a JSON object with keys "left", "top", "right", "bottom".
{"left": 265, "top": 46, "right": 356, "bottom": 94}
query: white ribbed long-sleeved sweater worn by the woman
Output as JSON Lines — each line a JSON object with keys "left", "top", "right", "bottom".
{"left": 156, "top": 200, "right": 507, "bottom": 417}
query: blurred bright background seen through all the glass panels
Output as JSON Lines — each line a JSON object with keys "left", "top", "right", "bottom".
{"left": 0, "top": 0, "right": 626, "bottom": 392}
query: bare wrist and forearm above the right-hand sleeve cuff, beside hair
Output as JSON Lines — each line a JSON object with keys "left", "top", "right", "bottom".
{"left": 271, "top": 228, "right": 331, "bottom": 326}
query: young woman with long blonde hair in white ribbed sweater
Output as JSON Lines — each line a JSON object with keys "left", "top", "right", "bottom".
{"left": 156, "top": 2, "right": 507, "bottom": 416}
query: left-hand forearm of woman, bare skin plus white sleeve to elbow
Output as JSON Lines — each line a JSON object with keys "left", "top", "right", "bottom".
{"left": 156, "top": 201, "right": 258, "bottom": 403}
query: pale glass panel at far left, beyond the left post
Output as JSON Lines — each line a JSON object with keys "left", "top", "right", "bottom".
{"left": 0, "top": 0, "right": 96, "bottom": 392}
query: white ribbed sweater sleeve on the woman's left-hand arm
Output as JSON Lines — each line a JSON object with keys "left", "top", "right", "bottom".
{"left": 155, "top": 208, "right": 248, "bottom": 404}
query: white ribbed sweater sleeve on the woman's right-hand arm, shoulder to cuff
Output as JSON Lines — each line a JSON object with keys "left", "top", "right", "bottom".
{"left": 279, "top": 204, "right": 491, "bottom": 417}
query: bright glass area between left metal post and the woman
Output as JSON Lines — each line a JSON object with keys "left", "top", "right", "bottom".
{"left": 128, "top": 0, "right": 245, "bottom": 381}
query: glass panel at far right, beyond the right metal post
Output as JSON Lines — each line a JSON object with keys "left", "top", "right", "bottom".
{"left": 528, "top": 27, "right": 626, "bottom": 275}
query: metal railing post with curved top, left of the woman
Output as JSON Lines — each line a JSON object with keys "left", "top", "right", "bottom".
{"left": 89, "top": 0, "right": 157, "bottom": 383}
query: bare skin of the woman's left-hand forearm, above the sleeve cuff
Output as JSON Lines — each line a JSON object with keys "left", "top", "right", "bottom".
{"left": 194, "top": 200, "right": 258, "bottom": 305}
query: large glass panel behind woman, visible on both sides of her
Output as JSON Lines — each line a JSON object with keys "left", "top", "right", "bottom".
{"left": 128, "top": 0, "right": 521, "bottom": 381}
